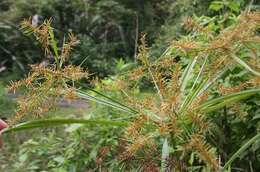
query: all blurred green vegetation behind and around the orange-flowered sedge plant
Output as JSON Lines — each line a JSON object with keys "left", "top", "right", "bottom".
{"left": 0, "top": 0, "right": 260, "bottom": 172}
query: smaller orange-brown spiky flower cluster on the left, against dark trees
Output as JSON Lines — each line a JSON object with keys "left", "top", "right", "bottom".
{"left": 9, "top": 19, "right": 89, "bottom": 125}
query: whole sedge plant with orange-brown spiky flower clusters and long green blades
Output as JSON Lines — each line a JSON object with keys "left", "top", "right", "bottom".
{"left": 4, "top": 12, "right": 260, "bottom": 171}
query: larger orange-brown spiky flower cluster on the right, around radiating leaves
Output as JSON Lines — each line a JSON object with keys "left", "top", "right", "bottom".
{"left": 110, "top": 12, "right": 260, "bottom": 171}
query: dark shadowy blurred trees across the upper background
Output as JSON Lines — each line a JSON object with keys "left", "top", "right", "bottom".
{"left": 0, "top": 0, "right": 189, "bottom": 77}
